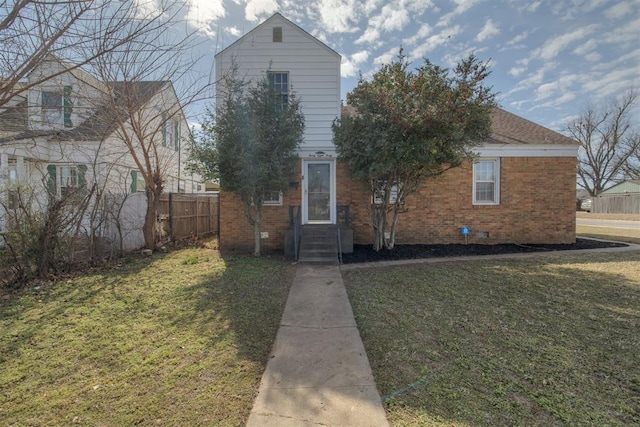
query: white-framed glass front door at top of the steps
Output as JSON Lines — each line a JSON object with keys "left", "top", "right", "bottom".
{"left": 302, "top": 160, "right": 336, "bottom": 224}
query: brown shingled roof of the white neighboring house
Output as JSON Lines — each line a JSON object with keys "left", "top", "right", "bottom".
{"left": 0, "top": 81, "right": 170, "bottom": 144}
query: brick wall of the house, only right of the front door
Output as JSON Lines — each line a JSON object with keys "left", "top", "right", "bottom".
{"left": 345, "top": 157, "right": 576, "bottom": 244}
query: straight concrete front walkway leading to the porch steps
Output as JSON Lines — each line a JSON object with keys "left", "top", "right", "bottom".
{"left": 247, "top": 265, "right": 388, "bottom": 427}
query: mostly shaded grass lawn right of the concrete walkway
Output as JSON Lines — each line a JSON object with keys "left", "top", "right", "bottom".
{"left": 343, "top": 251, "right": 640, "bottom": 426}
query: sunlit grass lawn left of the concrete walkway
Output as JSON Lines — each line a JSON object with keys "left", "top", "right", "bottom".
{"left": 0, "top": 249, "right": 294, "bottom": 426}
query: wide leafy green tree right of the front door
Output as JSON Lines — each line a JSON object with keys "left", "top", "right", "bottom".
{"left": 333, "top": 51, "right": 495, "bottom": 250}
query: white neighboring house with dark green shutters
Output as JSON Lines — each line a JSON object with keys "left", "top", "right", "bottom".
{"left": 0, "top": 56, "right": 204, "bottom": 251}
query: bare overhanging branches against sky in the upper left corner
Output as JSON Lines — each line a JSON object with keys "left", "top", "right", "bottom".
{"left": 0, "top": 0, "right": 180, "bottom": 108}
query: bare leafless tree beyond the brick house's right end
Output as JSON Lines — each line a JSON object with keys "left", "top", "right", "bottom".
{"left": 567, "top": 89, "right": 640, "bottom": 196}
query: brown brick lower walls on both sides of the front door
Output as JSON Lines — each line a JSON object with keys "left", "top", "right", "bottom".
{"left": 220, "top": 157, "right": 576, "bottom": 251}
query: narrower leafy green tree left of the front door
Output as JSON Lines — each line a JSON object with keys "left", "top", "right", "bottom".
{"left": 192, "top": 73, "right": 304, "bottom": 256}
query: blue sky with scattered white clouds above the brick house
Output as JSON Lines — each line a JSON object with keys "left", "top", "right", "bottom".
{"left": 178, "top": 0, "right": 640, "bottom": 130}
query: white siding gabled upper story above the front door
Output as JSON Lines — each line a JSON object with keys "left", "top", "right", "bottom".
{"left": 216, "top": 13, "right": 341, "bottom": 157}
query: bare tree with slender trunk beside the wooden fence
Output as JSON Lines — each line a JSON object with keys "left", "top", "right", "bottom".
{"left": 83, "top": 2, "right": 213, "bottom": 249}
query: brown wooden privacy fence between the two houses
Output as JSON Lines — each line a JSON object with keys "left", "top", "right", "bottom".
{"left": 159, "top": 193, "right": 220, "bottom": 240}
